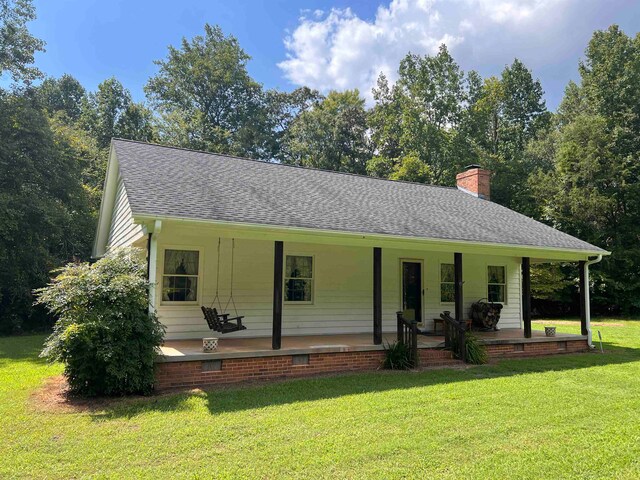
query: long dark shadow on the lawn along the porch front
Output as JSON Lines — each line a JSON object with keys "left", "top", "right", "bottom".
{"left": 92, "top": 343, "right": 640, "bottom": 421}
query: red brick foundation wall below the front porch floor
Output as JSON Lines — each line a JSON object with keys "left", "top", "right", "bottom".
{"left": 156, "top": 340, "right": 588, "bottom": 390}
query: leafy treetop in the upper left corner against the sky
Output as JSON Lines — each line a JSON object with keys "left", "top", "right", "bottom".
{"left": 0, "top": 0, "right": 44, "bottom": 83}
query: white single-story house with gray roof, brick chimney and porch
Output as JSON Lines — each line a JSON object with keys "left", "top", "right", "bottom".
{"left": 94, "top": 140, "right": 608, "bottom": 386}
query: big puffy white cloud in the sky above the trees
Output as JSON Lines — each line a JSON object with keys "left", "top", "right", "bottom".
{"left": 278, "top": 0, "right": 580, "bottom": 101}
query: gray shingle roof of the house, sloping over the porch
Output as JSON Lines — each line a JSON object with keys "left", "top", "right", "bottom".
{"left": 113, "top": 140, "right": 604, "bottom": 252}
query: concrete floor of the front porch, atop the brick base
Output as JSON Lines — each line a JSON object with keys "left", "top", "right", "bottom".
{"left": 157, "top": 328, "right": 586, "bottom": 362}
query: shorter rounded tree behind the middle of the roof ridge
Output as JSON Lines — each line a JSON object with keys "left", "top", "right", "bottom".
{"left": 288, "top": 90, "right": 371, "bottom": 174}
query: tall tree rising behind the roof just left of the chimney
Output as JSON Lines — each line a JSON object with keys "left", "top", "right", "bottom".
{"left": 368, "top": 45, "right": 473, "bottom": 185}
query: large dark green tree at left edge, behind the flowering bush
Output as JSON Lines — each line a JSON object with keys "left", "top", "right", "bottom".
{"left": 0, "top": 89, "right": 94, "bottom": 333}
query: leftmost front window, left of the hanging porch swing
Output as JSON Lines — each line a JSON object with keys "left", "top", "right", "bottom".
{"left": 162, "top": 250, "right": 200, "bottom": 302}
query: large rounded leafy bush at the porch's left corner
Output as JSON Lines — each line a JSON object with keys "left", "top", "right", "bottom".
{"left": 36, "top": 249, "right": 164, "bottom": 395}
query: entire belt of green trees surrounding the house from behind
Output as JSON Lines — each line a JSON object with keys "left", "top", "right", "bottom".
{"left": 0, "top": 0, "right": 640, "bottom": 332}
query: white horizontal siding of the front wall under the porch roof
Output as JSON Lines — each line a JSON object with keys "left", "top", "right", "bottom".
{"left": 157, "top": 222, "right": 520, "bottom": 339}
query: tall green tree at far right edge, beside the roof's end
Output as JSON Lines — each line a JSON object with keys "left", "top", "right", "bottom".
{"left": 530, "top": 26, "right": 640, "bottom": 312}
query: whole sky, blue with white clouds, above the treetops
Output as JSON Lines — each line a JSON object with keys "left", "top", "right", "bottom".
{"left": 30, "top": 0, "right": 640, "bottom": 109}
